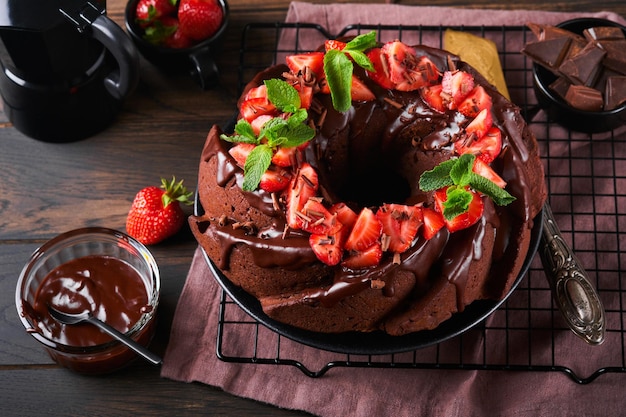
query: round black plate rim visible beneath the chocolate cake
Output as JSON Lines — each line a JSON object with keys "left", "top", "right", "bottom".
{"left": 194, "top": 193, "right": 543, "bottom": 355}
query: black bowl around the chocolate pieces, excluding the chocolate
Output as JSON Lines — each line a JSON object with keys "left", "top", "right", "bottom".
{"left": 532, "top": 18, "right": 626, "bottom": 133}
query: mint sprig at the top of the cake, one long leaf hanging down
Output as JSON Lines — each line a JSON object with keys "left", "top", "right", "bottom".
{"left": 324, "top": 31, "right": 377, "bottom": 112}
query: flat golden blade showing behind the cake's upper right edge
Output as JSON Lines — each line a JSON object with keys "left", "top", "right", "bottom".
{"left": 443, "top": 29, "right": 511, "bottom": 100}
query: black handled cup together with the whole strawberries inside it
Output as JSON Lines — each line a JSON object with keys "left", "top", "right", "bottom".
{"left": 125, "top": 0, "right": 228, "bottom": 89}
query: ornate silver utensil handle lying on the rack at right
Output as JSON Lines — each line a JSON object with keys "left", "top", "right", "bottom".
{"left": 540, "top": 203, "right": 605, "bottom": 345}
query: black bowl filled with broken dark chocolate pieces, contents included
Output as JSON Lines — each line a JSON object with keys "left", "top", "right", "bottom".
{"left": 522, "top": 18, "right": 626, "bottom": 133}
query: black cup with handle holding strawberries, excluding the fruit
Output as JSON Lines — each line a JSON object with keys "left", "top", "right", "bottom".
{"left": 124, "top": 0, "right": 229, "bottom": 90}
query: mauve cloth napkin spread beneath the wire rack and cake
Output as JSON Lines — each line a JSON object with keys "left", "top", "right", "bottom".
{"left": 161, "top": 3, "right": 626, "bottom": 417}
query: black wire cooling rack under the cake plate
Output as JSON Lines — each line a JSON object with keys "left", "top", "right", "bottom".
{"left": 217, "top": 23, "right": 626, "bottom": 384}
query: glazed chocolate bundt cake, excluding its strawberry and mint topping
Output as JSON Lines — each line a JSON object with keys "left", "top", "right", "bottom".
{"left": 190, "top": 46, "right": 546, "bottom": 335}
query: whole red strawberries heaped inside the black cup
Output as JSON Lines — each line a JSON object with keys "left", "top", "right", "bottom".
{"left": 135, "top": 0, "right": 224, "bottom": 48}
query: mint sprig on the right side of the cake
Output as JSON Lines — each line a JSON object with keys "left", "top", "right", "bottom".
{"left": 419, "top": 154, "right": 515, "bottom": 220}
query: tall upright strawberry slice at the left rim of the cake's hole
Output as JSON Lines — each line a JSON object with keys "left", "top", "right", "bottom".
{"left": 285, "top": 162, "right": 319, "bottom": 229}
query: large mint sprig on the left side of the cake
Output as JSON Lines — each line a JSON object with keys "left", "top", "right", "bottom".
{"left": 220, "top": 79, "right": 315, "bottom": 191}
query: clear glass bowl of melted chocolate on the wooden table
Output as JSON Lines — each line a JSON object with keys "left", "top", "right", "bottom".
{"left": 15, "top": 227, "right": 160, "bottom": 374}
